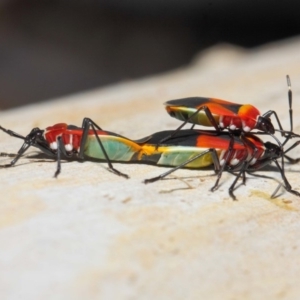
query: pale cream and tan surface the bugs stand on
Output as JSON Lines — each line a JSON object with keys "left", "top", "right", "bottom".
{"left": 0, "top": 39, "right": 300, "bottom": 300}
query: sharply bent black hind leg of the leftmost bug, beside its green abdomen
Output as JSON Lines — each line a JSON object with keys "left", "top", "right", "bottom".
{"left": 78, "top": 118, "right": 129, "bottom": 178}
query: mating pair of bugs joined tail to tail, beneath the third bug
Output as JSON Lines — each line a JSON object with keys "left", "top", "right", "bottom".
{"left": 0, "top": 118, "right": 299, "bottom": 199}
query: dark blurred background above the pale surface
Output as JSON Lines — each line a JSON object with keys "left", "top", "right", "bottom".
{"left": 0, "top": 0, "right": 300, "bottom": 109}
